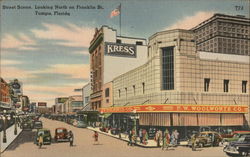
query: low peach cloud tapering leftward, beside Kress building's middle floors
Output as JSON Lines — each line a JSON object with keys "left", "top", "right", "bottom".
{"left": 34, "top": 64, "right": 89, "bottom": 79}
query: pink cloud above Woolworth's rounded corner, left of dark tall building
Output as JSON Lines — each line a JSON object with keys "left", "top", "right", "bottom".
{"left": 165, "top": 11, "right": 214, "bottom": 30}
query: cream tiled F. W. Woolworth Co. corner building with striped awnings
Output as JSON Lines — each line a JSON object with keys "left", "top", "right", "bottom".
{"left": 99, "top": 15, "right": 250, "bottom": 134}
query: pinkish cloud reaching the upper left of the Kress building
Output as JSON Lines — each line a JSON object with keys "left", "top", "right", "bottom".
{"left": 31, "top": 23, "right": 94, "bottom": 47}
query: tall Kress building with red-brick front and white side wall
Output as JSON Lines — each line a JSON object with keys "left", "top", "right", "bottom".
{"left": 89, "top": 26, "right": 147, "bottom": 110}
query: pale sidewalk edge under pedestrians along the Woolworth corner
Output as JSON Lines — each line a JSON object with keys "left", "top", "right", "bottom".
{"left": 87, "top": 127, "right": 157, "bottom": 148}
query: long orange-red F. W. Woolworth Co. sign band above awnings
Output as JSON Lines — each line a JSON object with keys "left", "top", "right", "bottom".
{"left": 99, "top": 104, "right": 248, "bottom": 113}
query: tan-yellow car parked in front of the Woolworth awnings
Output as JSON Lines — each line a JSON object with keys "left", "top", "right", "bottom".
{"left": 188, "top": 131, "right": 222, "bottom": 147}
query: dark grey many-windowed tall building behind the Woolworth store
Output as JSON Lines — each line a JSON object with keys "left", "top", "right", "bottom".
{"left": 192, "top": 14, "right": 250, "bottom": 55}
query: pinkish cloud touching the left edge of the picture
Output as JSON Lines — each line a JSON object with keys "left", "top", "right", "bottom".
{"left": 1, "top": 33, "right": 36, "bottom": 50}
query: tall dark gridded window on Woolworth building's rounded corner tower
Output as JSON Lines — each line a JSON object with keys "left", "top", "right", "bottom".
{"left": 162, "top": 47, "right": 174, "bottom": 90}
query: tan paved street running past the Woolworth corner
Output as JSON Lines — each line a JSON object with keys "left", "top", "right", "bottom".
{"left": 1, "top": 118, "right": 229, "bottom": 157}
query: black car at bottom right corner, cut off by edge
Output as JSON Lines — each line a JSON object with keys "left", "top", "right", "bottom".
{"left": 223, "top": 135, "right": 250, "bottom": 156}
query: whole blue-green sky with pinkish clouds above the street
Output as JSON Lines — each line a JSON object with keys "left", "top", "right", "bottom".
{"left": 0, "top": 0, "right": 249, "bottom": 106}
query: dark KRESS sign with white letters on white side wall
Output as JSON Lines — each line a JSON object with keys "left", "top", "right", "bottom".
{"left": 105, "top": 42, "right": 136, "bottom": 58}
